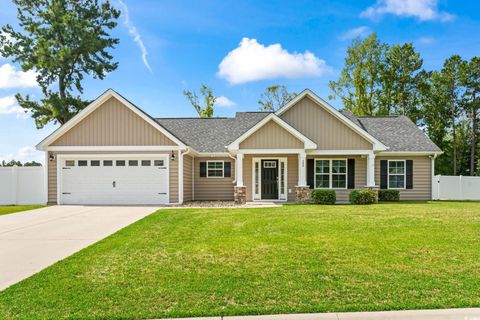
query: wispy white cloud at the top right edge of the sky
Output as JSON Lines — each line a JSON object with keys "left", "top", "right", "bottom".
{"left": 360, "top": 0, "right": 455, "bottom": 21}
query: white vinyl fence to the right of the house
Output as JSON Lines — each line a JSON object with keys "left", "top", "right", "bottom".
{"left": 432, "top": 175, "right": 480, "bottom": 200}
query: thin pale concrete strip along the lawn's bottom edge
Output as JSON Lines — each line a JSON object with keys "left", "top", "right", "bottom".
{"left": 154, "top": 308, "right": 480, "bottom": 320}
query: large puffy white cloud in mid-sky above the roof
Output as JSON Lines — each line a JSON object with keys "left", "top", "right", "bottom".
{"left": 217, "top": 38, "right": 330, "bottom": 84}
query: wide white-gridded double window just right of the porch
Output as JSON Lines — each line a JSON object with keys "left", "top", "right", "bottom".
{"left": 315, "top": 159, "right": 347, "bottom": 189}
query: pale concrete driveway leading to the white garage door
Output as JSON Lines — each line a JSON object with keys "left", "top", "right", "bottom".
{"left": 0, "top": 206, "right": 158, "bottom": 290}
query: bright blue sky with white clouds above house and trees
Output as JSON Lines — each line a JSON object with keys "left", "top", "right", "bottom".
{"left": 0, "top": 0, "right": 480, "bottom": 162}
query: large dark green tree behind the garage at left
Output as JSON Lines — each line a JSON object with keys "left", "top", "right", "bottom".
{"left": 0, "top": 0, "right": 120, "bottom": 128}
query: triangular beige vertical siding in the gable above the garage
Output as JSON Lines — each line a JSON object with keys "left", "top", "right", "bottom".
{"left": 51, "top": 97, "right": 176, "bottom": 146}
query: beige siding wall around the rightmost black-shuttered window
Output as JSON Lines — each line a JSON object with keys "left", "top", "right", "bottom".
{"left": 375, "top": 156, "right": 432, "bottom": 200}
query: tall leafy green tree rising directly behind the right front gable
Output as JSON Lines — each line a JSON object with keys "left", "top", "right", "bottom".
{"left": 329, "top": 33, "right": 388, "bottom": 115}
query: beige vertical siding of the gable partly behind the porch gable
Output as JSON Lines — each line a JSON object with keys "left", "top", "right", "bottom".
{"left": 280, "top": 97, "right": 372, "bottom": 150}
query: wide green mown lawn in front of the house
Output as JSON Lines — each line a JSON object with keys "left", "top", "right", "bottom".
{"left": 0, "top": 202, "right": 480, "bottom": 319}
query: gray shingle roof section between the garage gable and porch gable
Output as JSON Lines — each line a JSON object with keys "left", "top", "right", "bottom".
{"left": 155, "top": 112, "right": 269, "bottom": 152}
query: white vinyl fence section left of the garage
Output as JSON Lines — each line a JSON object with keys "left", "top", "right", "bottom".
{"left": 0, "top": 167, "right": 46, "bottom": 205}
